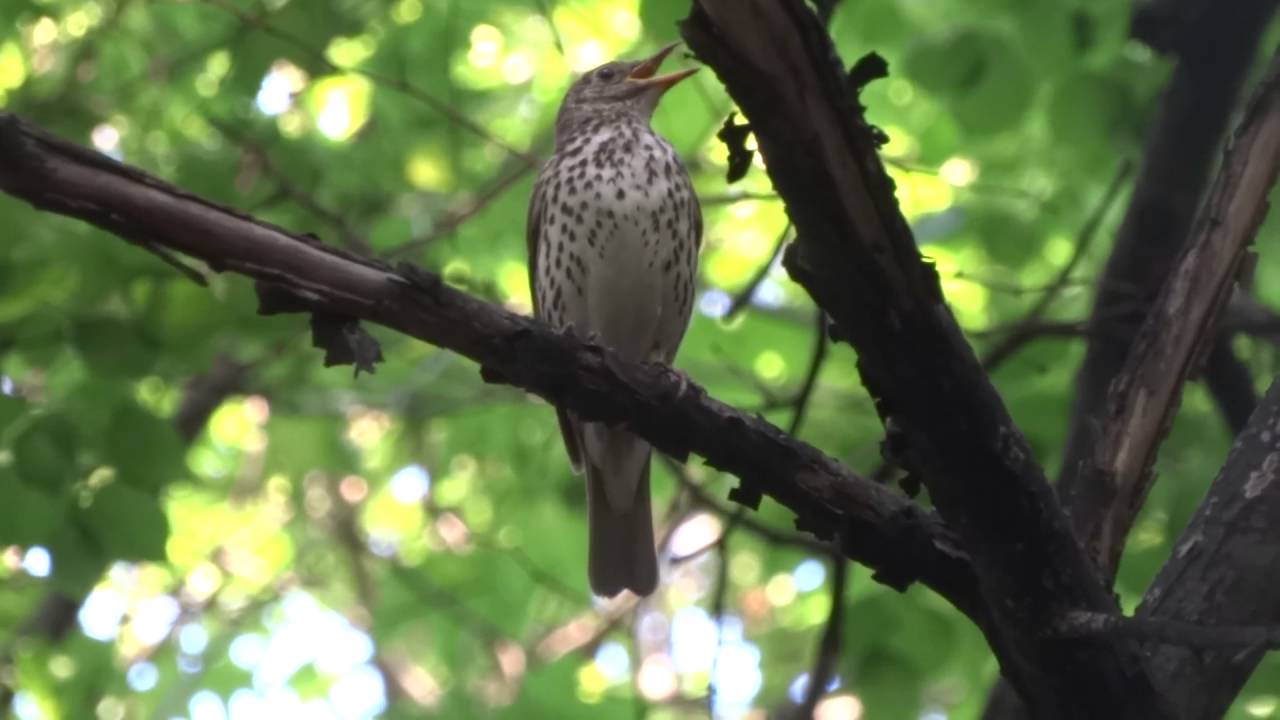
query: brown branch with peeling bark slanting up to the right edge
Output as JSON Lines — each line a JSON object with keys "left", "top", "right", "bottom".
{"left": 1078, "top": 50, "right": 1280, "bottom": 574}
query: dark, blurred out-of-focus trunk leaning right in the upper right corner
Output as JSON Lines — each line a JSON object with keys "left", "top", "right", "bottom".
{"left": 1059, "top": 0, "right": 1276, "bottom": 538}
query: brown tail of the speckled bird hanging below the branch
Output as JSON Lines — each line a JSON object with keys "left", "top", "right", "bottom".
{"left": 582, "top": 423, "right": 658, "bottom": 597}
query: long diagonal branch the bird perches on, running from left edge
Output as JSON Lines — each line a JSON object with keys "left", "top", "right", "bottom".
{"left": 0, "top": 113, "right": 984, "bottom": 624}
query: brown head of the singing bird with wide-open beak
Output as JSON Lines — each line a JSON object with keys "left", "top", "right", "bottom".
{"left": 556, "top": 42, "right": 698, "bottom": 137}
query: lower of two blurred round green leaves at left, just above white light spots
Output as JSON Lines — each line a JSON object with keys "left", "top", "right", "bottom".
{"left": 81, "top": 483, "right": 169, "bottom": 560}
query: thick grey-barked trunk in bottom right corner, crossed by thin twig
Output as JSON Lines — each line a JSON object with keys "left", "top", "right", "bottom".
{"left": 1138, "top": 382, "right": 1280, "bottom": 720}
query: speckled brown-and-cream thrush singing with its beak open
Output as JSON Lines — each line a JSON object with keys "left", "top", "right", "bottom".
{"left": 526, "top": 44, "right": 703, "bottom": 597}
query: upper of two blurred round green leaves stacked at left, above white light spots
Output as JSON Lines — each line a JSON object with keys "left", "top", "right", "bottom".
{"left": 102, "top": 402, "right": 186, "bottom": 493}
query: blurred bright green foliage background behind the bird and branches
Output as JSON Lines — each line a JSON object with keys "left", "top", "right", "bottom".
{"left": 0, "top": 0, "right": 1280, "bottom": 720}
